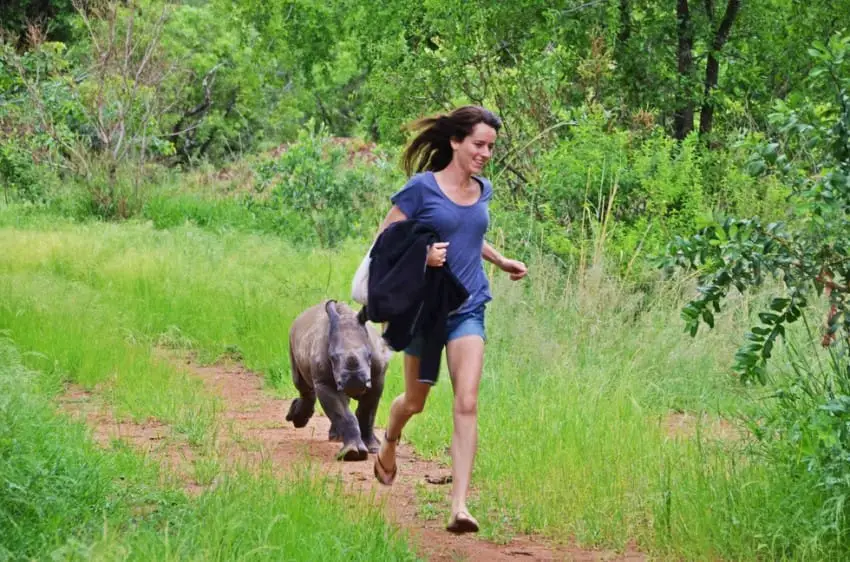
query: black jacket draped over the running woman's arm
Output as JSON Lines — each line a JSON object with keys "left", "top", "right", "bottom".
{"left": 354, "top": 219, "right": 469, "bottom": 380}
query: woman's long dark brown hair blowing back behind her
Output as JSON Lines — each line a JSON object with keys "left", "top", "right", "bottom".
{"left": 402, "top": 105, "right": 502, "bottom": 176}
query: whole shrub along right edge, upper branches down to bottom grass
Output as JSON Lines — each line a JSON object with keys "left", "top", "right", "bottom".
{"left": 665, "top": 35, "right": 850, "bottom": 537}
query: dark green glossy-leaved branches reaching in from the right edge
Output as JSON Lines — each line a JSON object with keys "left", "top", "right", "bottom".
{"left": 665, "top": 35, "right": 850, "bottom": 383}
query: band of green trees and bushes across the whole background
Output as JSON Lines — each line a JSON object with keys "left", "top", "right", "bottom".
{"left": 0, "top": 0, "right": 836, "bottom": 272}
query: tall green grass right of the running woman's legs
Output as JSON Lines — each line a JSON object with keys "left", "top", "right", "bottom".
{"left": 477, "top": 261, "right": 824, "bottom": 559}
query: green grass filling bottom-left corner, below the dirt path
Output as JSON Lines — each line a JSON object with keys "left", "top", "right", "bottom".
{"left": 0, "top": 324, "right": 415, "bottom": 561}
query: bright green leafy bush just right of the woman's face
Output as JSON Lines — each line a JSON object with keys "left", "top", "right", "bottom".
{"left": 495, "top": 111, "right": 788, "bottom": 266}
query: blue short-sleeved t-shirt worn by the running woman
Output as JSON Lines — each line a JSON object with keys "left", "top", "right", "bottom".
{"left": 390, "top": 168, "right": 493, "bottom": 314}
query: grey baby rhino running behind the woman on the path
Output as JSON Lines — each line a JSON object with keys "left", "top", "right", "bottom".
{"left": 286, "top": 300, "right": 391, "bottom": 461}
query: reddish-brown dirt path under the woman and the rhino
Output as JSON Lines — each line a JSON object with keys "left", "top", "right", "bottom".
{"left": 60, "top": 354, "right": 645, "bottom": 562}
